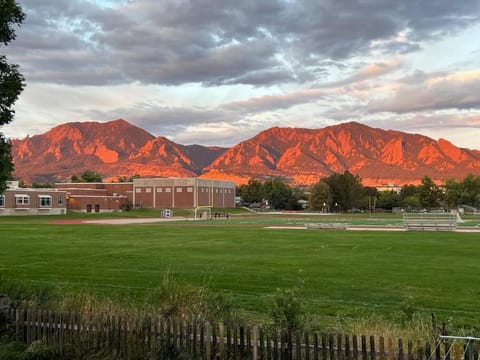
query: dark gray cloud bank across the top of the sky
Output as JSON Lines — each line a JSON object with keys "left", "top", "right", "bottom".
{"left": 7, "top": 0, "right": 480, "bottom": 86}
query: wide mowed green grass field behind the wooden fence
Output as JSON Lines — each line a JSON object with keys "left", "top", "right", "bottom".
{"left": 0, "top": 219, "right": 480, "bottom": 327}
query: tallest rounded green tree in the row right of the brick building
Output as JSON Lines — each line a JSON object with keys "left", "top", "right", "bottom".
{"left": 324, "top": 171, "right": 365, "bottom": 211}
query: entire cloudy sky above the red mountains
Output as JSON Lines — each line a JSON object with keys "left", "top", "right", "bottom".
{"left": 0, "top": 0, "right": 480, "bottom": 149}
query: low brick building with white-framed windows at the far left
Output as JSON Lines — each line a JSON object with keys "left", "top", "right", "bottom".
{"left": 0, "top": 181, "right": 67, "bottom": 216}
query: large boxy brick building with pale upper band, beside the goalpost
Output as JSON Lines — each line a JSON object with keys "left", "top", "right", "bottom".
{"left": 132, "top": 178, "right": 235, "bottom": 209}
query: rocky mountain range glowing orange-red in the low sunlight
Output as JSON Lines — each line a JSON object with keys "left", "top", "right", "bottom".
{"left": 13, "top": 120, "right": 480, "bottom": 185}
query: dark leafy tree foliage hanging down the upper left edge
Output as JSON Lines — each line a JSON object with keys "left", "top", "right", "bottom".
{"left": 0, "top": 0, "right": 25, "bottom": 193}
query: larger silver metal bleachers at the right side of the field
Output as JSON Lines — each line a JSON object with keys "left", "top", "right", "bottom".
{"left": 403, "top": 213, "right": 457, "bottom": 231}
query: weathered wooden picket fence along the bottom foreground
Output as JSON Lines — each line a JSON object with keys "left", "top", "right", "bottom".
{"left": 0, "top": 309, "right": 478, "bottom": 360}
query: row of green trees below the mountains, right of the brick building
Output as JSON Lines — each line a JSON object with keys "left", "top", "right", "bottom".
{"left": 237, "top": 171, "right": 480, "bottom": 212}
